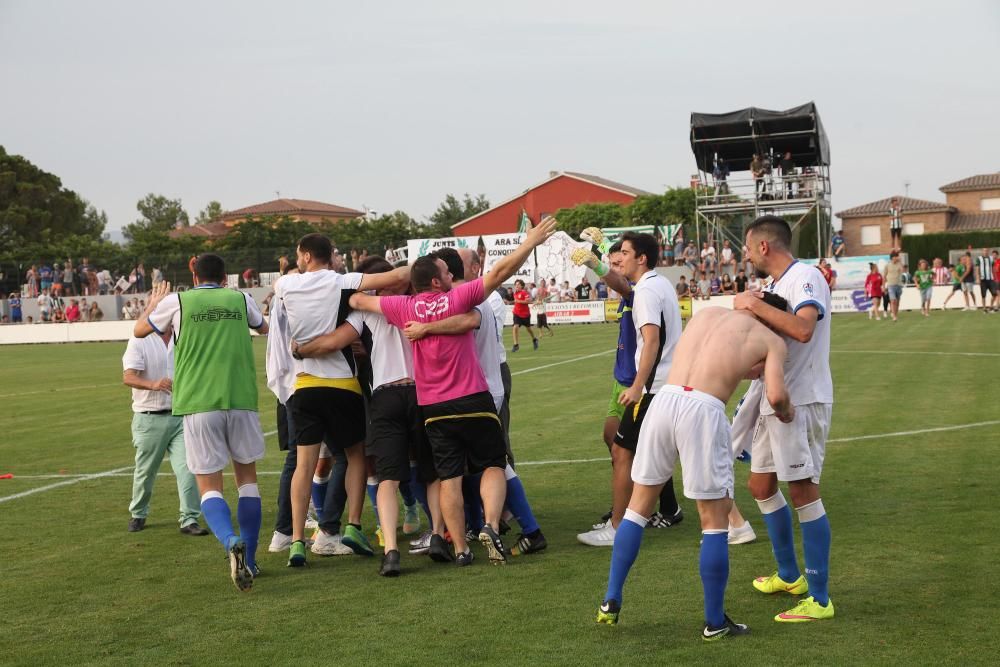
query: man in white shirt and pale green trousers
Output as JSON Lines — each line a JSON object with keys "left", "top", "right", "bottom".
{"left": 122, "top": 326, "right": 208, "bottom": 535}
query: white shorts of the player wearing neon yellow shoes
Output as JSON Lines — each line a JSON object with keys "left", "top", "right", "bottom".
{"left": 750, "top": 403, "right": 833, "bottom": 484}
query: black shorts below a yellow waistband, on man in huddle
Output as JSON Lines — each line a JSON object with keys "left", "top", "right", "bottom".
{"left": 286, "top": 387, "right": 365, "bottom": 449}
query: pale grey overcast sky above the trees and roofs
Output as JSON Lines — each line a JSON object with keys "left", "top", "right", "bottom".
{"left": 0, "top": 0, "right": 1000, "bottom": 237}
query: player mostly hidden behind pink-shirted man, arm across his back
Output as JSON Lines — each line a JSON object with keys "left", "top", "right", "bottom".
{"left": 406, "top": 248, "right": 548, "bottom": 556}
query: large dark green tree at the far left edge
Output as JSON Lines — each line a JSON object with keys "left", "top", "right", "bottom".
{"left": 0, "top": 146, "right": 100, "bottom": 257}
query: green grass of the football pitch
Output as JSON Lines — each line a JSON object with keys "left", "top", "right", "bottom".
{"left": 0, "top": 313, "right": 1000, "bottom": 665}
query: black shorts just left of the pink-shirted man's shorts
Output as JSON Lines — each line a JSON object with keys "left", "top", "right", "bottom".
{"left": 365, "top": 384, "right": 434, "bottom": 482}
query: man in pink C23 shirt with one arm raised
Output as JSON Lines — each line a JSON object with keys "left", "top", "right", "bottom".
{"left": 350, "top": 218, "right": 556, "bottom": 566}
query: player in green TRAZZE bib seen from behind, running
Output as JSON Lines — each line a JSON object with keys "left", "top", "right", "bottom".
{"left": 133, "top": 253, "right": 267, "bottom": 591}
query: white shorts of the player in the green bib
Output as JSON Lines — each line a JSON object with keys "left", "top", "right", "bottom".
{"left": 184, "top": 410, "right": 264, "bottom": 475}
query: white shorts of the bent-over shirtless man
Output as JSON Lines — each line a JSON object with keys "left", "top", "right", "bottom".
{"left": 632, "top": 384, "right": 734, "bottom": 500}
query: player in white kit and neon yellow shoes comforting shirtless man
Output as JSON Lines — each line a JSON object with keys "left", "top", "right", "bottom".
{"left": 733, "top": 215, "right": 834, "bottom": 623}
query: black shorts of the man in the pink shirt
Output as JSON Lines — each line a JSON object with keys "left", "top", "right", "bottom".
{"left": 423, "top": 391, "right": 507, "bottom": 479}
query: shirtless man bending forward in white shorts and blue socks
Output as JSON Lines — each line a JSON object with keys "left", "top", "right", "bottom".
{"left": 597, "top": 294, "right": 794, "bottom": 641}
